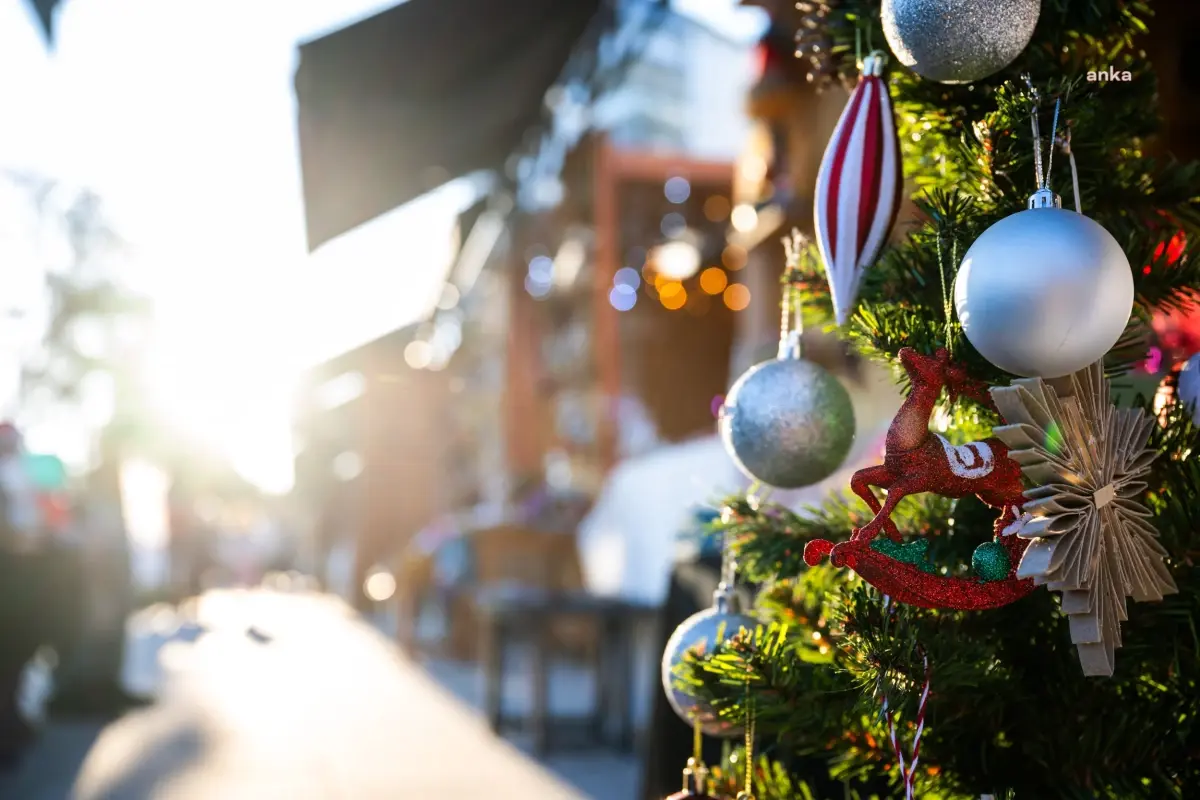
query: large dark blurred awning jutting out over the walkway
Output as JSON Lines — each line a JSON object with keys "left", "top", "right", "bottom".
{"left": 295, "top": 0, "right": 601, "bottom": 249}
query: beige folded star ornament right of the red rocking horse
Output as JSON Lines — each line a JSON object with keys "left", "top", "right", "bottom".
{"left": 991, "top": 362, "right": 1177, "bottom": 675}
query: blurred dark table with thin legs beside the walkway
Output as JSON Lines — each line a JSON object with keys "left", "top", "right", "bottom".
{"left": 478, "top": 593, "right": 659, "bottom": 756}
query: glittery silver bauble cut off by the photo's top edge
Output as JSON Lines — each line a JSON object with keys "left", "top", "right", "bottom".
{"left": 881, "top": 0, "right": 1042, "bottom": 83}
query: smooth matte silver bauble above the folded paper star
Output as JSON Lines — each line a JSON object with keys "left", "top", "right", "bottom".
{"left": 954, "top": 190, "right": 1133, "bottom": 378}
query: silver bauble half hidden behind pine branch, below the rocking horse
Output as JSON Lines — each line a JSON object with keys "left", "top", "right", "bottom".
{"left": 662, "top": 588, "right": 758, "bottom": 739}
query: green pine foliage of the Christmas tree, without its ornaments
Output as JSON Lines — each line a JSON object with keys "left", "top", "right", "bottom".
{"left": 679, "top": 0, "right": 1200, "bottom": 800}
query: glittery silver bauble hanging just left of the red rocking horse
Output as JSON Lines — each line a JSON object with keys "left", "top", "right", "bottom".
{"left": 720, "top": 355, "right": 854, "bottom": 489}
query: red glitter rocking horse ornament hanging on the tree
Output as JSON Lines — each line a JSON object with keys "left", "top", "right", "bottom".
{"left": 804, "top": 348, "right": 1033, "bottom": 610}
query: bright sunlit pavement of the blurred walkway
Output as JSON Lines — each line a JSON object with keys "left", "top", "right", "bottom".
{"left": 0, "top": 591, "right": 583, "bottom": 800}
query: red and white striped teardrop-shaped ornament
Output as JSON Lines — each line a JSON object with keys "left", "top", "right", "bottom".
{"left": 814, "top": 52, "right": 904, "bottom": 325}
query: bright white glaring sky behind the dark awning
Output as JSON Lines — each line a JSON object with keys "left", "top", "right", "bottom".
{"left": 0, "top": 0, "right": 761, "bottom": 492}
